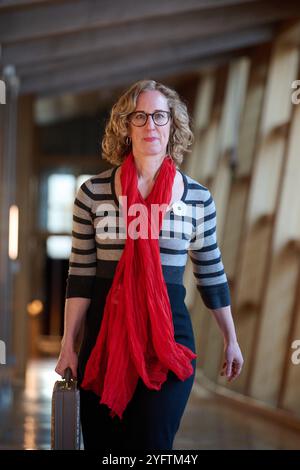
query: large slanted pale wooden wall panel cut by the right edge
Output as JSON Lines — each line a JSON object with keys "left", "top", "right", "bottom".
{"left": 250, "top": 92, "right": 300, "bottom": 405}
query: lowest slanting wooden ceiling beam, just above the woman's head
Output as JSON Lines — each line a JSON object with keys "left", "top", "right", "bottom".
{"left": 20, "top": 27, "right": 272, "bottom": 93}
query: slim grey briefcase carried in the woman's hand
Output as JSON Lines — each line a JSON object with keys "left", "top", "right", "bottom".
{"left": 51, "top": 367, "right": 81, "bottom": 450}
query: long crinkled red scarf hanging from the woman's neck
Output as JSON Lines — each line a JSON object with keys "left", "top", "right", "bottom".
{"left": 81, "top": 153, "right": 197, "bottom": 419}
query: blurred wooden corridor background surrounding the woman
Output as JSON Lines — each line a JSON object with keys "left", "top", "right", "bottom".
{"left": 0, "top": 0, "right": 300, "bottom": 449}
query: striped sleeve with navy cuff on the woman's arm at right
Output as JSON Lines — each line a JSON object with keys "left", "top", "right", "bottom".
{"left": 188, "top": 187, "right": 230, "bottom": 309}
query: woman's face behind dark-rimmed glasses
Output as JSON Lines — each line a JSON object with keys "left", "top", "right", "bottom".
{"left": 129, "top": 90, "right": 171, "bottom": 160}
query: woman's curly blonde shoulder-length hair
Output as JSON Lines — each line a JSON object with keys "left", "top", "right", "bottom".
{"left": 102, "top": 80, "right": 194, "bottom": 166}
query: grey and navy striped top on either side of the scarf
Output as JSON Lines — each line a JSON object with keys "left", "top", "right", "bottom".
{"left": 66, "top": 166, "right": 230, "bottom": 309}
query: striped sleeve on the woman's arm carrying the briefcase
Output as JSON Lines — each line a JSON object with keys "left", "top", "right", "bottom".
{"left": 66, "top": 179, "right": 97, "bottom": 298}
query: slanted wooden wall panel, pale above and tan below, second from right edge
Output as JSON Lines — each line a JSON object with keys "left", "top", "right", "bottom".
{"left": 235, "top": 136, "right": 285, "bottom": 308}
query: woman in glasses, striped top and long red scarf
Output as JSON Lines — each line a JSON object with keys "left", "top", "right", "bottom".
{"left": 55, "top": 80, "right": 243, "bottom": 450}
